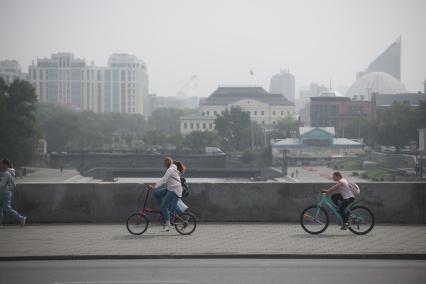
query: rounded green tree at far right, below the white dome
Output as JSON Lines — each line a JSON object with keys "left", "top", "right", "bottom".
{"left": 377, "top": 103, "right": 417, "bottom": 150}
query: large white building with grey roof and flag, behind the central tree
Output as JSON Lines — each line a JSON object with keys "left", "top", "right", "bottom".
{"left": 180, "top": 86, "right": 295, "bottom": 135}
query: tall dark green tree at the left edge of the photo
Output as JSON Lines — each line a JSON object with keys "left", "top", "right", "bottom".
{"left": 0, "top": 78, "right": 39, "bottom": 166}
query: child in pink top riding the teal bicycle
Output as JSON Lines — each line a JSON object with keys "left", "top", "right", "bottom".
{"left": 322, "top": 172, "right": 355, "bottom": 230}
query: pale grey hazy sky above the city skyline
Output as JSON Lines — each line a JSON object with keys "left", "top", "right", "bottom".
{"left": 0, "top": 0, "right": 426, "bottom": 96}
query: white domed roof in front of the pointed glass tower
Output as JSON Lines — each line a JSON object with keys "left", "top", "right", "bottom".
{"left": 346, "top": 72, "right": 407, "bottom": 99}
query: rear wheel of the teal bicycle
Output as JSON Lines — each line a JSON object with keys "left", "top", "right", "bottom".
{"left": 348, "top": 206, "right": 375, "bottom": 235}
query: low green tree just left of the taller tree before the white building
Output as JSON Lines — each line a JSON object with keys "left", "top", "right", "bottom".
{"left": 183, "top": 131, "right": 220, "bottom": 154}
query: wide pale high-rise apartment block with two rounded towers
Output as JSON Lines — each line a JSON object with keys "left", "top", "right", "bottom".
{"left": 28, "top": 53, "right": 148, "bottom": 114}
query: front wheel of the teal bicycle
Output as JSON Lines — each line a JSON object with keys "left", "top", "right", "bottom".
{"left": 300, "top": 205, "right": 329, "bottom": 235}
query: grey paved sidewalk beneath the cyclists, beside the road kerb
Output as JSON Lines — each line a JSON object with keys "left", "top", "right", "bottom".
{"left": 0, "top": 223, "right": 426, "bottom": 259}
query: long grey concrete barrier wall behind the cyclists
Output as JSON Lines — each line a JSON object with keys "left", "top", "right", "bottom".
{"left": 9, "top": 182, "right": 426, "bottom": 224}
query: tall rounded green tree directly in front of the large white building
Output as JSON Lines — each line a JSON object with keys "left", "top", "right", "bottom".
{"left": 215, "top": 107, "right": 256, "bottom": 151}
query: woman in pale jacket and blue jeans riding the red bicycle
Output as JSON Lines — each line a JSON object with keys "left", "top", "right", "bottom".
{"left": 150, "top": 157, "right": 185, "bottom": 232}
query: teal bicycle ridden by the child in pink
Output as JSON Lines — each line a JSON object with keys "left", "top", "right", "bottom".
{"left": 300, "top": 192, "right": 374, "bottom": 235}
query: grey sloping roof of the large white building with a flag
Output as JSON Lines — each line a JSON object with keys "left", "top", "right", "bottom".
{"left": 201, "top": 87, "right": 293, "bottom": 105}
